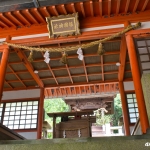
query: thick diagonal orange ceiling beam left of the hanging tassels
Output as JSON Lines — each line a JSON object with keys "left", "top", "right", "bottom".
{"left": 15, "top": 49, "right": 44, "bottom": 88}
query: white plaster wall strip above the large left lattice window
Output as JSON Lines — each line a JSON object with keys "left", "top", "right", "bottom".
{"left": 2, "top": 89, "right": 40, "bottom": 100}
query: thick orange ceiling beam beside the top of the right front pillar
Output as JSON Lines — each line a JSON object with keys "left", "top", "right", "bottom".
{"left": 118, "top": 36, "right": 127, "bottom": 81}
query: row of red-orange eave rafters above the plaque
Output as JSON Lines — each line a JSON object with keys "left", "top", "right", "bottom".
{"left": 0, "top": 0, "right": 150, "bottom": 30}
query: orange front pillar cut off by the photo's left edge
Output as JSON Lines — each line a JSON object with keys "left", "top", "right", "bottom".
{"left": 0, "top": 46, "right": 9, "bottom": 103}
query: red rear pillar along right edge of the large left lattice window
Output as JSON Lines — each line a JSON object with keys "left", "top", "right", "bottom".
{"left": 37, "top": 88, "right": 44, "bottom": 139}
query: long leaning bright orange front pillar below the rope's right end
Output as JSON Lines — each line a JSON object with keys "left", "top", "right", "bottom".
{"left": 126, "top": 35, "right": 149, "bottom": 133}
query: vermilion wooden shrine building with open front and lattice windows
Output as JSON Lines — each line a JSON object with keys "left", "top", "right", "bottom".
{"left": 0, "top": 0, "right": 150, "bottom": 142}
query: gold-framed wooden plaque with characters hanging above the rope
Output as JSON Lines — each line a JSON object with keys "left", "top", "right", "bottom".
{"left": 46, "top": 13, "right": 80, "bottom": 38}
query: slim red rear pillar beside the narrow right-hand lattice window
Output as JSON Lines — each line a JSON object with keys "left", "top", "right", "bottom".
{"left": 119, "top": 81, "right": 130, "bottom": 136}
